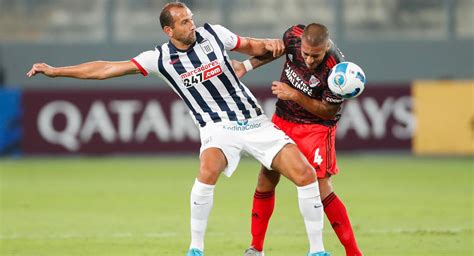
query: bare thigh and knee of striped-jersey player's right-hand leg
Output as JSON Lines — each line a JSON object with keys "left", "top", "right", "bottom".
{"left": 272, "top": 144, "right": 316, "bottom": 186}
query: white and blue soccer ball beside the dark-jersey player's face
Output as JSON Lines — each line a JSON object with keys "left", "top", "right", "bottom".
{"left": 328, "top": 61, "right": 365, "bottom": 99}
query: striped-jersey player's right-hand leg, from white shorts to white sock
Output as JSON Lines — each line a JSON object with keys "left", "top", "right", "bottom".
{"left": 245, "top": 117, "right": 329, "bottom": 256}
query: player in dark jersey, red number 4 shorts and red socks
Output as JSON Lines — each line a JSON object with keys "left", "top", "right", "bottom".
{"left": 233, "top": 23, "right": 362, "bottom": 256}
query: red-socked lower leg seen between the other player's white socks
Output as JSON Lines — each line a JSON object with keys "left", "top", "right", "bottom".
{"left": 244, "top": 166, "right": 280, "bottom": 253}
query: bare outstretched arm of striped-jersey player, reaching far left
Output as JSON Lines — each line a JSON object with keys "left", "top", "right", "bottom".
{"left": 26, "top": 61, "right": 140, "bottom": 80}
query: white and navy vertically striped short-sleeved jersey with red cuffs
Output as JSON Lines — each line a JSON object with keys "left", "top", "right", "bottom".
{"left": 132, "top": 23, "right": 263, "bottom": 127}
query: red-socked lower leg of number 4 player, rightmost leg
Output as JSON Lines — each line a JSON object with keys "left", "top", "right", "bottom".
{"left": 318, "top": 175, "right": 362, "bottom": 256}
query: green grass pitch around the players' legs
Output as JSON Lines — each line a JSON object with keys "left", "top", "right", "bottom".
{"left": 0, "top": 155, "right": 474, "bottom": 256}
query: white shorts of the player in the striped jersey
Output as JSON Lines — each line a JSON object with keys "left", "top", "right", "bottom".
{"left": 200, "top": 115, "right": 295, "bottom": 177}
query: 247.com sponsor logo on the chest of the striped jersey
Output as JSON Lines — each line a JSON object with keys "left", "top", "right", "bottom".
{"left": 180, "top": 60, "right": 222, "bottom": 88}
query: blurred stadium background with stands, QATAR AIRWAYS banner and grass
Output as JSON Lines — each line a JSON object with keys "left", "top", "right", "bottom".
{"left": 0, "top": 0, "right": 474, "bottom": 256}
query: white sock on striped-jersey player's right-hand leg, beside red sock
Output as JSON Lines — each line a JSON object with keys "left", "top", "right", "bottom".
{"left": 297, "top": 181, "right": 324, "bottom": 253}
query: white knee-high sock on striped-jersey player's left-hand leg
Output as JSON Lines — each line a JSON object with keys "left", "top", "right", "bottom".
{"left": 189, "top": 179, "right": 215, "bottom": 251}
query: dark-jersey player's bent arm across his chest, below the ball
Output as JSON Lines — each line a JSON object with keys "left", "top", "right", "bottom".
{"left": 272, "top": 81, "right": 341, "bottom": 119}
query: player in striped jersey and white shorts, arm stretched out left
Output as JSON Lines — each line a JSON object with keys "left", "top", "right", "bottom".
{"left": 27, "top": 2, "right": 329, "bottom": 256}
